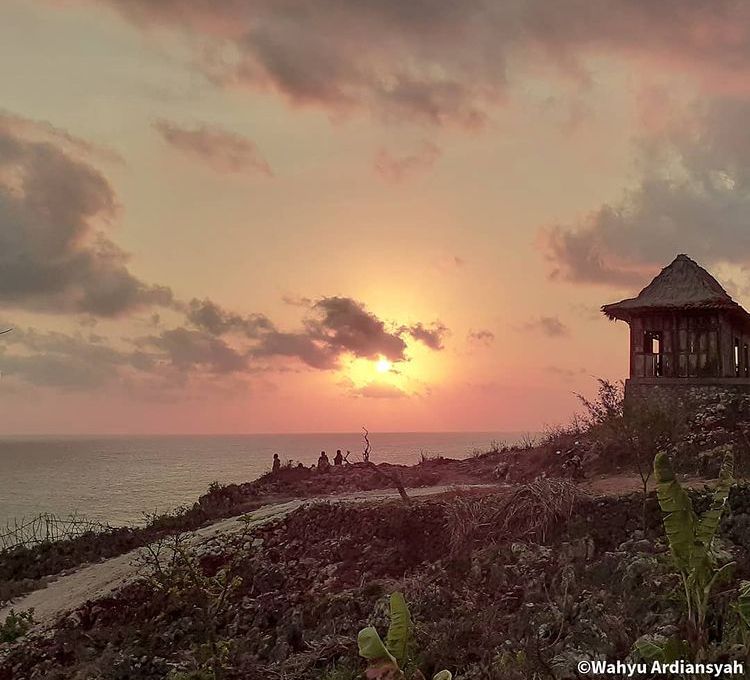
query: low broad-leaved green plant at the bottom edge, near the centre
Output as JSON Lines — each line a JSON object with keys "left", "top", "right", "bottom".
{"left": 357, "top": 592, "right": 453, "bottom": 680}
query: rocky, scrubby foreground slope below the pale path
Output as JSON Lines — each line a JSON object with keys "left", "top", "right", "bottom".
{"left": 0, "top": 480, "right": 750, "bottom": 680}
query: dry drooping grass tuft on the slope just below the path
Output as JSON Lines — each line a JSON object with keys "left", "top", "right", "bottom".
{"left": 448, "top": 479, "right": 585, "bottom": 555}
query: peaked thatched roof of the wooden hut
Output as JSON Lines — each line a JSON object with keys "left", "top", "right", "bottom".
{"left": 602, "top": 255, "right": 750, "bottom": 321}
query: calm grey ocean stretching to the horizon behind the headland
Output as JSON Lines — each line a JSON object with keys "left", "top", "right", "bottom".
{"left": 0, "top": 432, "right": 526, "bottom": 529}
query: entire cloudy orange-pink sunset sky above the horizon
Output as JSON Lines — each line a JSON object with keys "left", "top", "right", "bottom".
{"left": 0, "top": 0, "right": 750, "bottom": 434}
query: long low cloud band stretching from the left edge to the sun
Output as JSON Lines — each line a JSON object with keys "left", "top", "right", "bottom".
{"left": 0, "top": 288, "right": 447, "bottom": 391}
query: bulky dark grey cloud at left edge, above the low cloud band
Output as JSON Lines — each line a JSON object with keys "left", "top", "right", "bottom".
{"left": 0, "top": 116, "right": 172, "bottom": 316}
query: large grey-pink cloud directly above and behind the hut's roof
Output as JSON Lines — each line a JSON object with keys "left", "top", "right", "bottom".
{"left": 541, "top": 98, "right": 750, "bottom": 285}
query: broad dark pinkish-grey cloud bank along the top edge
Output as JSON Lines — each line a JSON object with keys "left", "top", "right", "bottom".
{"left": 90, "top": 0, "right": 750, "bottom": 127}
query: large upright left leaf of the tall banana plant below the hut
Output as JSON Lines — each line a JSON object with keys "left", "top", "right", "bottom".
{"left": 654, "top": 452, "right": 697, "bottom": 572}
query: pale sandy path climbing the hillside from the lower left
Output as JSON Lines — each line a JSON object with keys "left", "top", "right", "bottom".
{"left": 0, "top": 484, "right": 494, "bottom": 625}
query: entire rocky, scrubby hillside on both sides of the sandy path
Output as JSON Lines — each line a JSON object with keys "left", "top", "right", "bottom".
{"left": 7, "top": 383, "right": 750, "bottom": 680}
